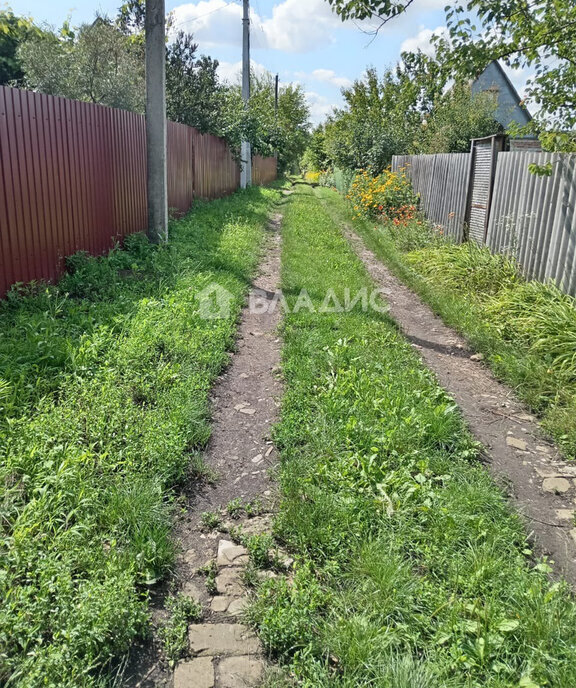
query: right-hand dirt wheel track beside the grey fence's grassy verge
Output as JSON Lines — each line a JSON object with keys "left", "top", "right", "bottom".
{"left": 345, "top": 228, "right": 576, "bottom": 586}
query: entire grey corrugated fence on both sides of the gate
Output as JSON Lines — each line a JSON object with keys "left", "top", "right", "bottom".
{"left": 392, "top": 151, "right": 576, "bottom": 296}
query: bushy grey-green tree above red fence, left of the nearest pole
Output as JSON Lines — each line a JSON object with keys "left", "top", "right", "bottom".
{"left": 17, "top": 17, "right": 144, "bottom": 112}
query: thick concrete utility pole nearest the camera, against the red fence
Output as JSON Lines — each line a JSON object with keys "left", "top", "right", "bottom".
{"left": 145, "top": 0, "right": 168, "bottom": 244}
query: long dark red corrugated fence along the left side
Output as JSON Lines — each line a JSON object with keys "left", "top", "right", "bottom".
{"left": 0, "top": 86, "right": 276, "bottom": 296}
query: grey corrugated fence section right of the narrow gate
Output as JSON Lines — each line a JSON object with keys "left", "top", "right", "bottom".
{"left": 486, "top": 152, "right": 576, "bottom": 295}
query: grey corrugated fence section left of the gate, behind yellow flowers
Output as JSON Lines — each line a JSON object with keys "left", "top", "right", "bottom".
{"left": 392, "top": 153, "right": 470, "bottom": 241}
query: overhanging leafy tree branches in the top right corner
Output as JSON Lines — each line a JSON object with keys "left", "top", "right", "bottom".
{"left": 328, "top": 0, "right": 576, "bottom": 150}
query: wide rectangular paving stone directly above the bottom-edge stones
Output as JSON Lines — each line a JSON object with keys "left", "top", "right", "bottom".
{"left": 188, "top": 624, "right": 260, "bottom": 657}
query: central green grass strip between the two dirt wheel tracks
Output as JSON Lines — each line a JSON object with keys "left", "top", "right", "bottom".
{"left": 250, "top": 185, "right": 576, "bottom": 688}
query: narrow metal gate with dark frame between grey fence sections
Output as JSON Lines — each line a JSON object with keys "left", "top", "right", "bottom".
{"left": 466, "top": 134, "right": 505, "bottom": 244}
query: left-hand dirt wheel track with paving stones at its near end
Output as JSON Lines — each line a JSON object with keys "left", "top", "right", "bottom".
{"left": 124, "top": 215, "right": 282, "bottom": 688}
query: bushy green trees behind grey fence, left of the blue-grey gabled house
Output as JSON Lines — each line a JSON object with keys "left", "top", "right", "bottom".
{"left": 312, "top": 53, "right": 501, "bottom": 174}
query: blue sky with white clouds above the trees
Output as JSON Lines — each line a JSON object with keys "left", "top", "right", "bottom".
{"left": 8, "top": 0, "right": 525, "bottom": 123}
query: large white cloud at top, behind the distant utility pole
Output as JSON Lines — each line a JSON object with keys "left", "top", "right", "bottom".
{"left": 172, "top": 0, "right": 342, "bottom": 53}
